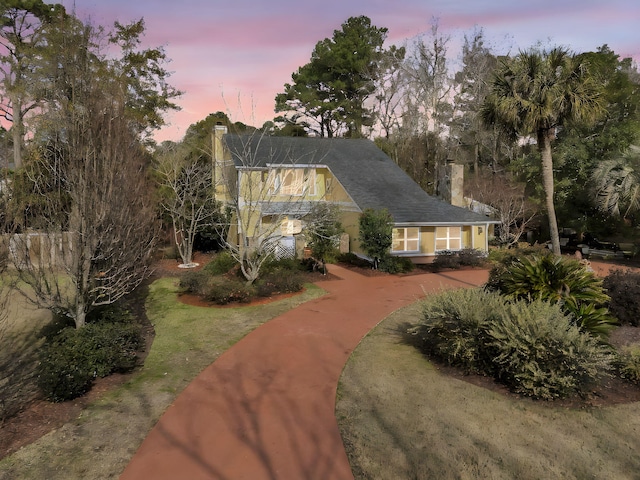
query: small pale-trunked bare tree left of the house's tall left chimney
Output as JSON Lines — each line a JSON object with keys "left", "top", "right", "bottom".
{"left": 157, "top": 145, "right": 219, "bottom": 268}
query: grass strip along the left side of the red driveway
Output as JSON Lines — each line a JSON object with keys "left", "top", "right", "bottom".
{"left": 0, "top": 278, "right": 323, "bottom": 480}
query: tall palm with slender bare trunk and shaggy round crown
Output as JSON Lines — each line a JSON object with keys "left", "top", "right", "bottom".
{"left": 481, "top": 47, "right": 603, "bottom": 255}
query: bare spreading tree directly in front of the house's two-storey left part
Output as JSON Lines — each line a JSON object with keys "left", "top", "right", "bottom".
{"left": 219, "top": 129, "right": 330, "bottom": 283}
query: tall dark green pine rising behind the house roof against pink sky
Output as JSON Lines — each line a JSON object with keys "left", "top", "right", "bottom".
{"left": 276, "top": 16, "right": 387, "bottom": 137}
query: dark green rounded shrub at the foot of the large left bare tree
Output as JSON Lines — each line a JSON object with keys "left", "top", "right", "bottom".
{"left": 37, "top": 321, "right": 142, "bottom": 402}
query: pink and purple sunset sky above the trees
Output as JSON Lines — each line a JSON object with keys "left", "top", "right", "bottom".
{"left": 61, "top": 0, "right": 640, "bottom": 141}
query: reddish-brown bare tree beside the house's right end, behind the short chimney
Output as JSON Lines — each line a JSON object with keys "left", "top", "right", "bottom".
{"left": 466, "top": 172, "right": 539, "bottom": 246}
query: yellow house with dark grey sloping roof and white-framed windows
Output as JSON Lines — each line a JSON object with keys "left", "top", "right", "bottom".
{"left": 214, "top": 126, "right": 497, "bottom": 263}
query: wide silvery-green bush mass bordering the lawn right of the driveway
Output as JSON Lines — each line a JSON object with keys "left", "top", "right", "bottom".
{"left": 408, "top": 289, "right": 612, "bottom": 400}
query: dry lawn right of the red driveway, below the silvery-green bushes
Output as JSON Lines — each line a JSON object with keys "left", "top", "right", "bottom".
{"left": 336, "top": 304, "right": 640, "bottom": 480}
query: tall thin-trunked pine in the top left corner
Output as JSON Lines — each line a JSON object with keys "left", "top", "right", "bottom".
{"left": 0, "top": 0, "right": 65, "bottom": 168}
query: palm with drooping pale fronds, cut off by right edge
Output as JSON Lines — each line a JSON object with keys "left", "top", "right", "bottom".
{"left": 593, "top": 145, "right": 640, "bottom": 218}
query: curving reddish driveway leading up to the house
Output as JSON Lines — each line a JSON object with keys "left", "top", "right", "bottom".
{"left": 121, "top": 266, "right": 487, "bottom": 480}
